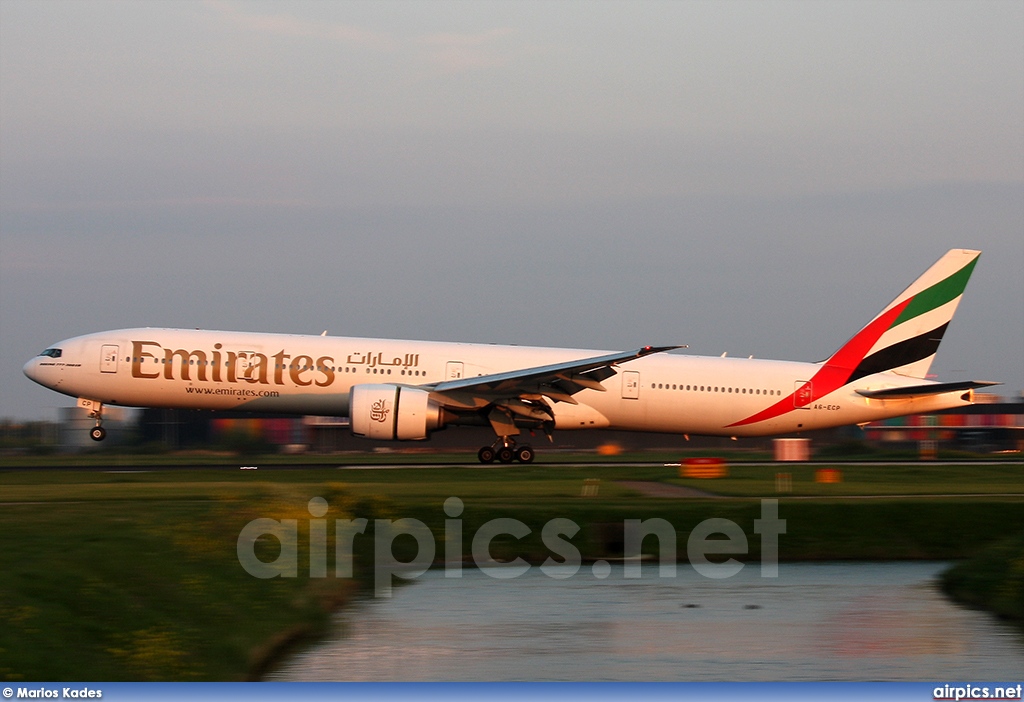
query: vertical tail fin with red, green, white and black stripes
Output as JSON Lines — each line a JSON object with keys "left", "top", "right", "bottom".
{"left": 825, "top": 249, "right": 981, "bottom": 383}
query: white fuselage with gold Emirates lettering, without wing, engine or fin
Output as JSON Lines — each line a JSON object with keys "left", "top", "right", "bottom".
{"left": 25, "top": 328, "right": 970, "bottom": 436}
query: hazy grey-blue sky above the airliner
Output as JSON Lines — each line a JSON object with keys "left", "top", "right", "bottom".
{"left": 0, "top": 0, "right": 1024, "bottom": 419}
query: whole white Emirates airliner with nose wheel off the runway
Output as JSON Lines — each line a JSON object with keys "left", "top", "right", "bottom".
{"left": 24, "top": 249, "right": 997, "bottom": 464}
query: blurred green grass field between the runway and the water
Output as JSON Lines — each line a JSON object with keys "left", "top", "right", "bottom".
{"left": 0, "top": 458, "right": 1024, "bottom": 681}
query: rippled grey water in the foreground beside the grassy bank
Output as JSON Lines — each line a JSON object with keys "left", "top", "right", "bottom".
{"left": 273, "top": 563, "right": 1024, "bottom": 681}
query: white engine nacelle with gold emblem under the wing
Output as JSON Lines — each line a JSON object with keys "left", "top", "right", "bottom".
{"left": 348, "top": 384, "right": 445, "bottom": 441}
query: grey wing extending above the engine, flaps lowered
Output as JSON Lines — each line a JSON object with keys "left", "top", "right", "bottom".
{"left": 419, "top": 346, "right": 684, "bottom": 436}
